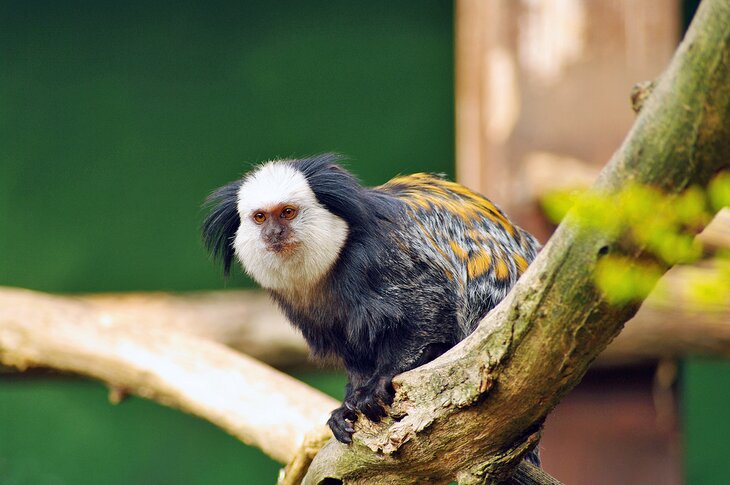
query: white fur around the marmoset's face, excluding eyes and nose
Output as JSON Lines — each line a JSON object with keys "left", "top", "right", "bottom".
{"left": 233, "top": 161, "right": 348, "bottom": 291}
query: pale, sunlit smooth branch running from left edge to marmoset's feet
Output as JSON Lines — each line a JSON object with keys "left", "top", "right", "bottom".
{"left": 0, "top": 289, "right": 338, "bottom": 463}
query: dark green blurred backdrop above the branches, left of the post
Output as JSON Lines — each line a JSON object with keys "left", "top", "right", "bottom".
{"left": 0, "top": 1, "right": 453, "bottom": 291}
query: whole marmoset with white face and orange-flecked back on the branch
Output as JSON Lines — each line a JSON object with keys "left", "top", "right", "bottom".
{"left": 203, "top": 154, "right": 539, "bottom": 443}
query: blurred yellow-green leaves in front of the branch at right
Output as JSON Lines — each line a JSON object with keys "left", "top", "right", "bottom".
{"left": 542, "top": 172, "right": 730, "bottom": 307}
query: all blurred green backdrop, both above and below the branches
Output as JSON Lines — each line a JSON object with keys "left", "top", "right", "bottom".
{"left": 0, "top": 0, "right": 730, "bottom": 485}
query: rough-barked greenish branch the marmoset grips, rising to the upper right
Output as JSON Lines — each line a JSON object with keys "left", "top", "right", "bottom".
{"left": 305, "top": 0, "right": 730, "bottom": 484}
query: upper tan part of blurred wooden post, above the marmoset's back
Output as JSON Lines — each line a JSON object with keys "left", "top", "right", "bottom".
{"left": 456, "top": 0, "right": 680, "bottom": 240}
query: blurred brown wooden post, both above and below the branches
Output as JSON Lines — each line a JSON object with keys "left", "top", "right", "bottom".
{"left": 455, "top": 0, "right": 681, "bottom": 484}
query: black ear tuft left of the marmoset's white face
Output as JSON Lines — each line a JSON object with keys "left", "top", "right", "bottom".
{"left": 202, "top": 180, "right": 241, "bottom": 277}
